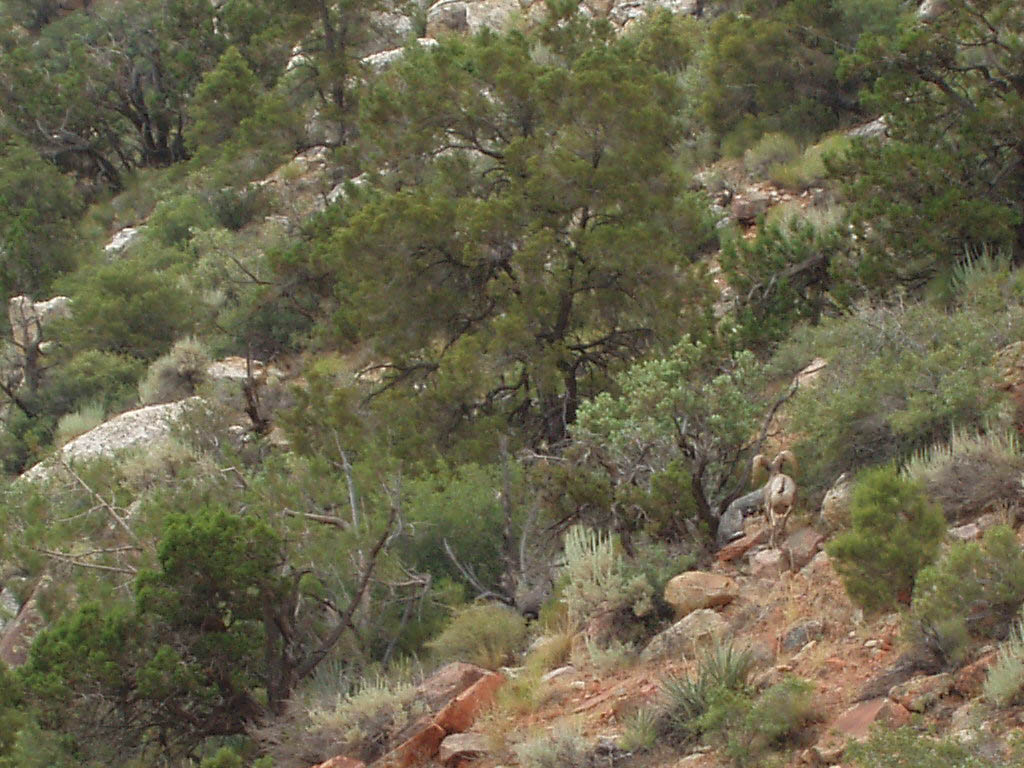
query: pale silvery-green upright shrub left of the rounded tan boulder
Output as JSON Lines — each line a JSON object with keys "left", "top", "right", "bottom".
{"left": 563, "top": 525, "right": 653, "bottom": 638}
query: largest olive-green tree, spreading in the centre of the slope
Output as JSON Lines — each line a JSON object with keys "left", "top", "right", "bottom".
{"left": 278, "top": 25, "right": 711, "bottom": 444}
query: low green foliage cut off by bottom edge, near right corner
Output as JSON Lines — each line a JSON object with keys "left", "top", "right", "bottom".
{"left": 846, "top": 728, "right": 1006, "bottom": 768}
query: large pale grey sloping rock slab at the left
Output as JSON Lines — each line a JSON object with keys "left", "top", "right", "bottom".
{"left": 20, "top": 397, "right": 203, "bottom": 481}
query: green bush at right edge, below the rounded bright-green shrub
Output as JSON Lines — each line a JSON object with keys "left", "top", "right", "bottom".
{"left": 906, "top": 525, "right": 1024, "bottom": 664}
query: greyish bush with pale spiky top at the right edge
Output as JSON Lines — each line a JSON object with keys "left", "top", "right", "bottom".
{"left": 904, "top": 430, "right": 1024, "bottom": 522}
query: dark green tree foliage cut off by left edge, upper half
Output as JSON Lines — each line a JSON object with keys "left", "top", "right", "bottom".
{"left": 0, "top": 140, "right": 82, "bottom": 306}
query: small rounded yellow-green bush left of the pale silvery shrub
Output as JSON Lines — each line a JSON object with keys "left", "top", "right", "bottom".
{"left": 427, "top": 603, "right": 526, "bottom": 670}
